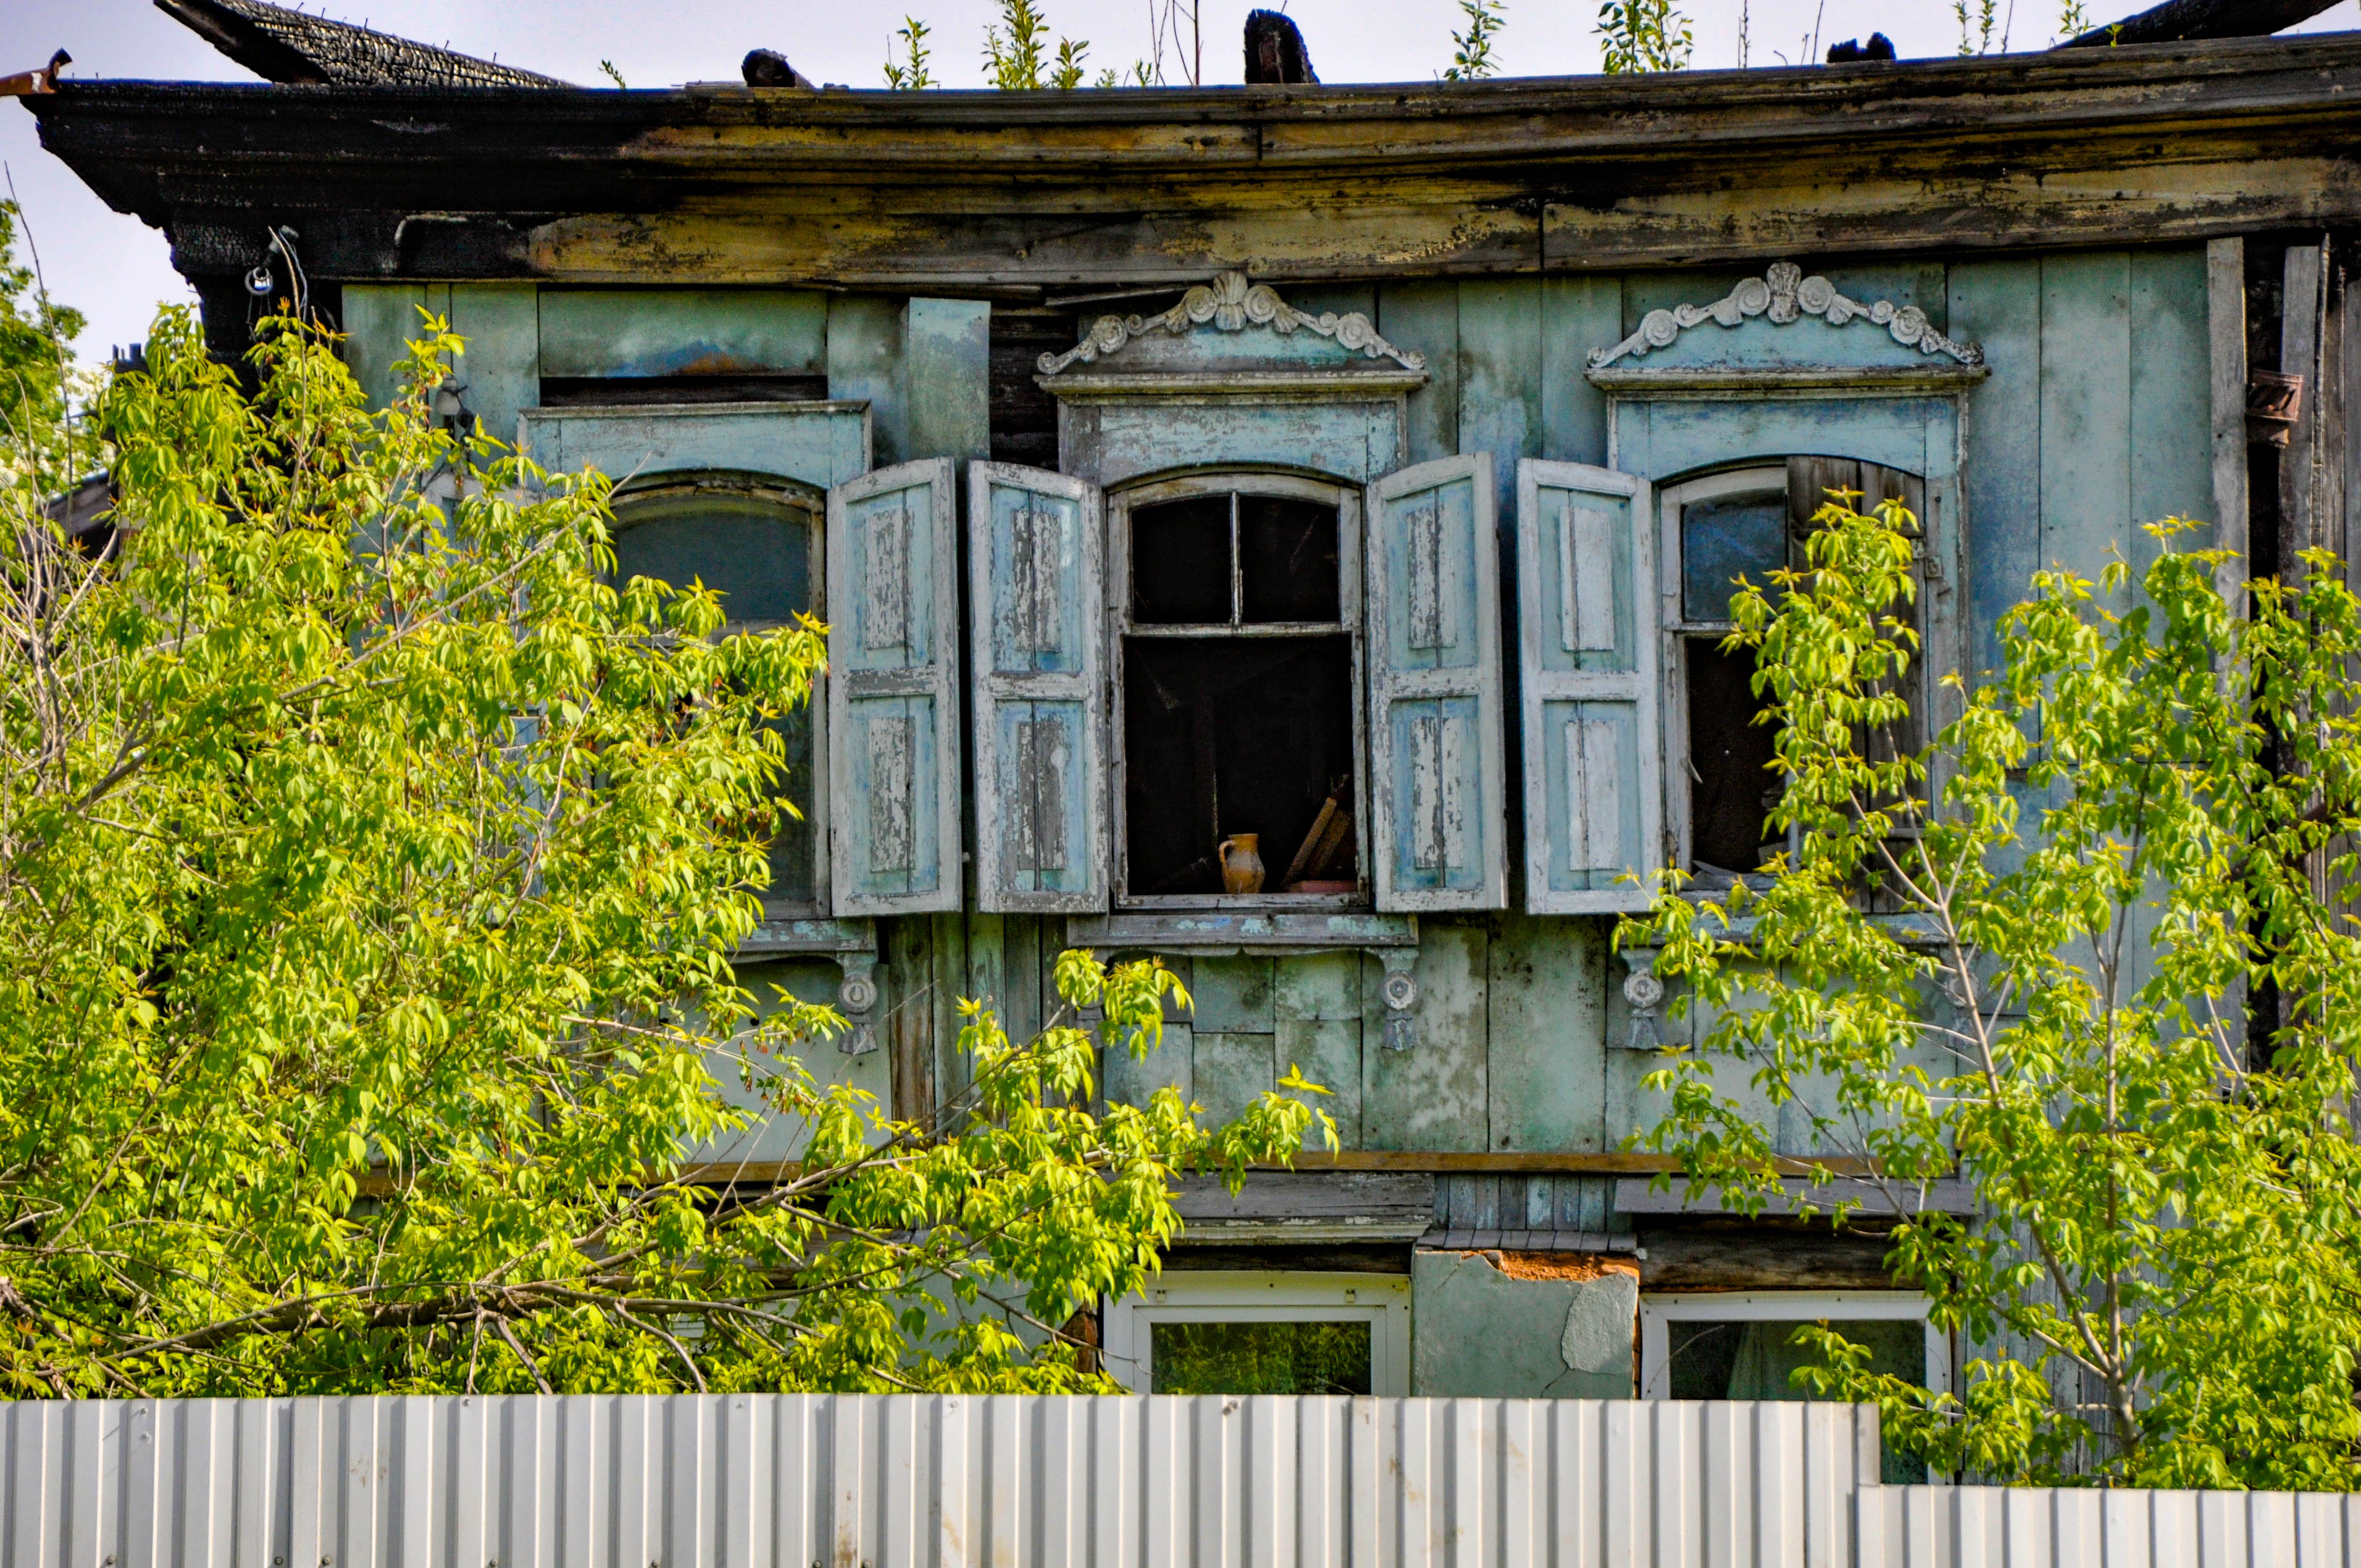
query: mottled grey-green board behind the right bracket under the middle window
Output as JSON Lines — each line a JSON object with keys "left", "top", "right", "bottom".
{"left": 1360, "top": 921, "right": 1490, "bottom": 1150}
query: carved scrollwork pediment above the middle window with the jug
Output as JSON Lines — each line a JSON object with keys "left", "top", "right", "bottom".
{"left": 1037, "top": 272, "right": 1426, "bottom": 397}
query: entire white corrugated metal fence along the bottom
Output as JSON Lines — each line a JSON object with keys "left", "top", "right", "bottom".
{"left": 18, "top": 1393, "right": 2361, "bottom": 1568}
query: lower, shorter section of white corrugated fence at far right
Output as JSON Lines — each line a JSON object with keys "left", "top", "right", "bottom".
{"left": 1858, "top": 1485, "right": 2361, "bottom": 1568}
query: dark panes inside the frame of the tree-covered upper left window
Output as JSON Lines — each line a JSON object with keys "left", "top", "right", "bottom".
{"left": 614, "top": 486, "right": 819, "bottom": 904}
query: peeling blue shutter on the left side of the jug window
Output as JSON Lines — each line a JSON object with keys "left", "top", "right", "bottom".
{"left": 968, "top": 463, "right": 1107, "bottom": 914}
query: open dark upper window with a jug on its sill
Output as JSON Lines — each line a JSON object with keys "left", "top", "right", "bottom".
{"left": 1112, "top": 475, "right": 1367, "bottom": 904}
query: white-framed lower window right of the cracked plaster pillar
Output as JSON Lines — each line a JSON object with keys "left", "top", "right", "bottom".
{"left": 1639, "top": 1290, "right": 1952, "bottom": 1485}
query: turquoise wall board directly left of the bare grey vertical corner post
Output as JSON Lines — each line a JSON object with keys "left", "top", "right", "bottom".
{"left": 2123, "top": 246, "right": 2215, "bottom": 576}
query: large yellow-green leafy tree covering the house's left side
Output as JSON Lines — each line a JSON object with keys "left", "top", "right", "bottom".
{"left": 0, "top": 312, "right": 1332, "bottom": 1398}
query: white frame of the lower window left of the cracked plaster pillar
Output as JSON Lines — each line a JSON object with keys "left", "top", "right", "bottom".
{"left": 1100, "top": 1270, "right": 1410, "bottom": 1398}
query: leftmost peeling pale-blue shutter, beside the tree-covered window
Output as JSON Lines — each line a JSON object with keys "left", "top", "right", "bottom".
{"left": 829, "top": 458, "right": 961, "bottom": 916}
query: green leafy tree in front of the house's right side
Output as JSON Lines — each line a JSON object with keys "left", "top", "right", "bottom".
{"left": 1617, "top": 498, "right": 2361, "bottom": 1490}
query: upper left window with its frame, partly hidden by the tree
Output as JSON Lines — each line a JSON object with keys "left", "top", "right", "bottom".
{"left": 614, "top": 475, "right": 826, "bottom": 916}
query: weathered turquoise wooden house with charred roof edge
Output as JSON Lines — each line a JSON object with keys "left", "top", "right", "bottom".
{"left": 28, "top": 0, "right": 2361, "bottom": 1398}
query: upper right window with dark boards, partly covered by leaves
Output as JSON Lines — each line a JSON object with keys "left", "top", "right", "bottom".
{"left": 1660, "top": 458, "right": 1926, "bottom": 893}
